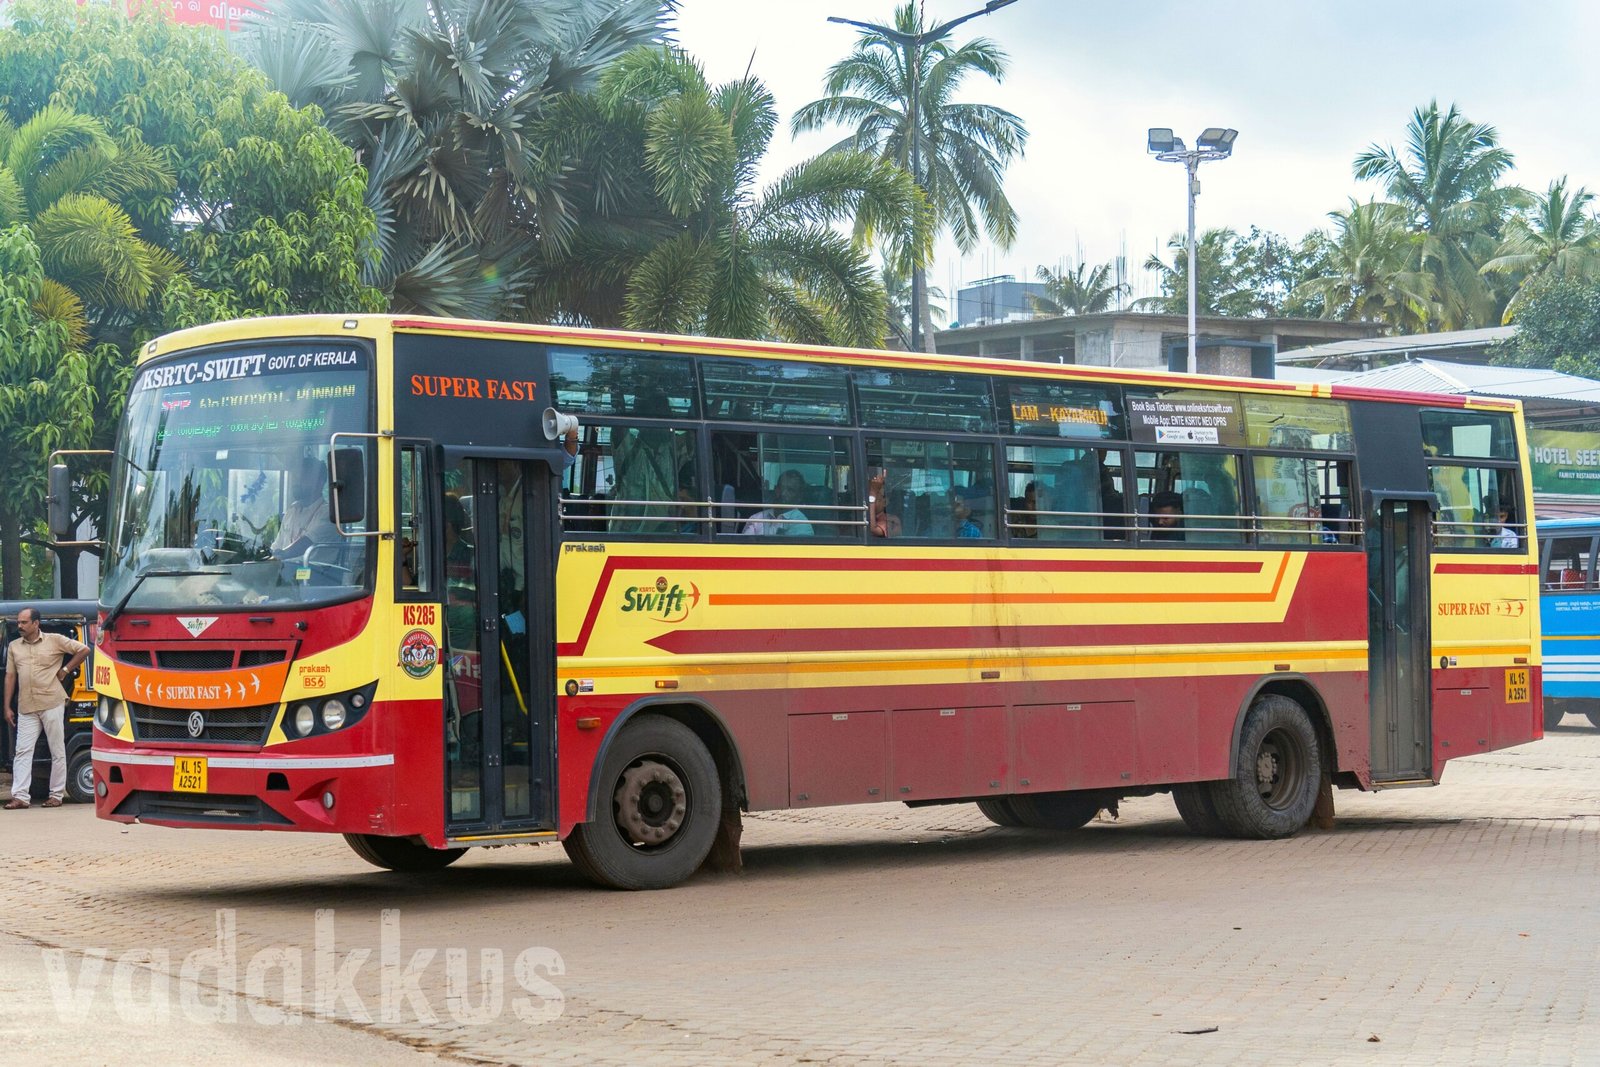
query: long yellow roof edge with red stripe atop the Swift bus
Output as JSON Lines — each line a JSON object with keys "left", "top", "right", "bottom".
{"left": 139, "top": 314, "right": 1522, "bottom": 411}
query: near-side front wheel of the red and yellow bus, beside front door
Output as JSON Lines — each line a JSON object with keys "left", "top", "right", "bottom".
{"left": 562, "top": 715, "right": 722, "bottom": 889}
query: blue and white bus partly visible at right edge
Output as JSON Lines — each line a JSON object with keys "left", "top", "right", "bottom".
{"left": 1539, "top": 517, "right": 1600, "bottom": 729}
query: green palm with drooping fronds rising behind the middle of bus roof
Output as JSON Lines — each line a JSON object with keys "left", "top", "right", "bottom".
{"left": 595, "top": 48, "right": 931, "bottom": 346}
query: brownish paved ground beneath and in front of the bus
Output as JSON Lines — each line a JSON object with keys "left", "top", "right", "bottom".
{"left": 0, "top": 717, "right": 1600, "bottom": 1065}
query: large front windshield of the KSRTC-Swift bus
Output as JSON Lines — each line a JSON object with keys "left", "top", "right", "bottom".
{"left": 101, "top": 341, "right": 371, "bottom": 611}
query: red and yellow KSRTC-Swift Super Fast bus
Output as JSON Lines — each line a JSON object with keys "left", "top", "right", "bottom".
{"left": 94, "top": 315, "right": 1541, "bottom": 888}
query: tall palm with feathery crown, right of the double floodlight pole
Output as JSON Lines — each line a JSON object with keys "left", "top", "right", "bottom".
{"left": 1355, "top": 101, "right": 1526, "bottom": 330}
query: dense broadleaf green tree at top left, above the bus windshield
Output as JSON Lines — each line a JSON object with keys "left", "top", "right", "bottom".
{"left": 0, "top": 0, "right": 382, "bottom": 334}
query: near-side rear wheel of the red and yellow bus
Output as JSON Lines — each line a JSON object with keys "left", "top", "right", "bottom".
{"left": 1210, "top": 696, "right": 1322, "bottom": 838}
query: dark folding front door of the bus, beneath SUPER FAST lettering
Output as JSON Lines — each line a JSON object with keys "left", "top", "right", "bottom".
{"left": 443, "top": 458, "right": 555, "bottom": 838}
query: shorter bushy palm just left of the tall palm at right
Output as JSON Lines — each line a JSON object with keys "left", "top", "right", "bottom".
{"left": 1294, "top": 198, "right": 1434, "bottom": 333}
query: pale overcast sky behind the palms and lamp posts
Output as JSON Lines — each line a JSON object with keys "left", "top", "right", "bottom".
{"left": 678, "top": 0, "right": 1600, "bottom": 308}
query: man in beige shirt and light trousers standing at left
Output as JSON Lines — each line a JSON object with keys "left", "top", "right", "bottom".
{"left": 5, "top": 608, "right": 90, "bottom": 811}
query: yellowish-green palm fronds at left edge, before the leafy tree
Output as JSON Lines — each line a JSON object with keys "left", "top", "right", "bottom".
{"left": 0, "top": 104, "right": 182, "bottom": 347}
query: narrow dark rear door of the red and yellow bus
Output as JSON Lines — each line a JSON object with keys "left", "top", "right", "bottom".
{"left": 1366, "top": 499, "right": 1432, "bottom": 784}
